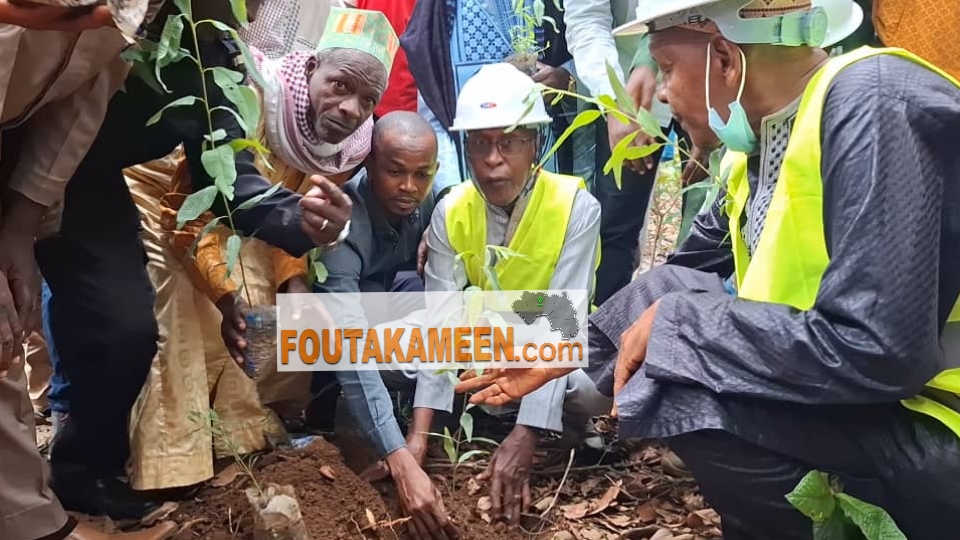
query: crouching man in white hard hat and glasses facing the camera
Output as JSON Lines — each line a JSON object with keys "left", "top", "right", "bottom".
{"left": 414, "top": 64, "right": 610, "bottom": 524}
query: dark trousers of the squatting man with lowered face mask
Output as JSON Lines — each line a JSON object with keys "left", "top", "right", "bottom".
{"left": 667, "top": 399, "right": 960, "bottom": 540}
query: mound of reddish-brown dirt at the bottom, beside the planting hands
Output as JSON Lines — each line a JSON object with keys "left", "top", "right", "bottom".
{"left": 171, "top": 439, "right": 402, "bottom": 540}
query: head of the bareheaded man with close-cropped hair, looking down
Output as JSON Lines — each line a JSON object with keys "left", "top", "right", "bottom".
{"left": 367, "top": 111, "right": 439, "bottom": 222}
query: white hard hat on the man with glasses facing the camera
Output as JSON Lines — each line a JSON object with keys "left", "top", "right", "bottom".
{"left": 450, "top": 63, "right": 553, "bottom": 131}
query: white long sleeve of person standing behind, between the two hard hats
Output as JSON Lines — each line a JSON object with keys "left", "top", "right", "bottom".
{"left": 563, "top": 0, "right": 672, "bottom": 126}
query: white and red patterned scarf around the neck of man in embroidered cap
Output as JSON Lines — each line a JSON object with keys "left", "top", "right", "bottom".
{"left": 251, "top": 48, "right": 373, "bottom": 174}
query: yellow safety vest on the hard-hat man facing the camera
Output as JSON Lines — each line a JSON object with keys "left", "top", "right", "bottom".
{"left": 446, "top": 171, "right": 600, "bottom": 297}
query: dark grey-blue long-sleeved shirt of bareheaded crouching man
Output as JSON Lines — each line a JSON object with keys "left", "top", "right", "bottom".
{"left": 314, "top": 170, "right": 433, "bottom": 457}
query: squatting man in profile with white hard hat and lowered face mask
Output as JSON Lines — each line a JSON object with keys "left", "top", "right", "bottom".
{"left": 459, "top": 0, "right": 960, "bottom": 540}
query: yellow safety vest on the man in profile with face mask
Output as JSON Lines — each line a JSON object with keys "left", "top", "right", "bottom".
{"left": 721, "top": 47, "right": 960, "bottom": 436}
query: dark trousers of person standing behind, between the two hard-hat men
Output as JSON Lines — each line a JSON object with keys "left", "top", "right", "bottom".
{"left": 593, "top": 119, "right": 663, "bottom": 306}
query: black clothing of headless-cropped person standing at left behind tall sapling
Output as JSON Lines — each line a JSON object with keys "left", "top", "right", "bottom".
{"left": 36, "top": 38, "right": 240, "bottom": 481}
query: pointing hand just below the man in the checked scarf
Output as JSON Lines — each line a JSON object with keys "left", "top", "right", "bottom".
{"left": 300, "top": 174, "right": 353, "bottom": 246}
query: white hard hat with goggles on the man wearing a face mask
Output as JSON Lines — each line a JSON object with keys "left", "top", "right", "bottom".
{"left": 613, "top": 0, "right": 863, "bottom": 47}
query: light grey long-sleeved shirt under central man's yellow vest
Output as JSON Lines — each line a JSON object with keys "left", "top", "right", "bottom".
{"left": 414, "top": 175, "right": 600, "bottom": 432}
